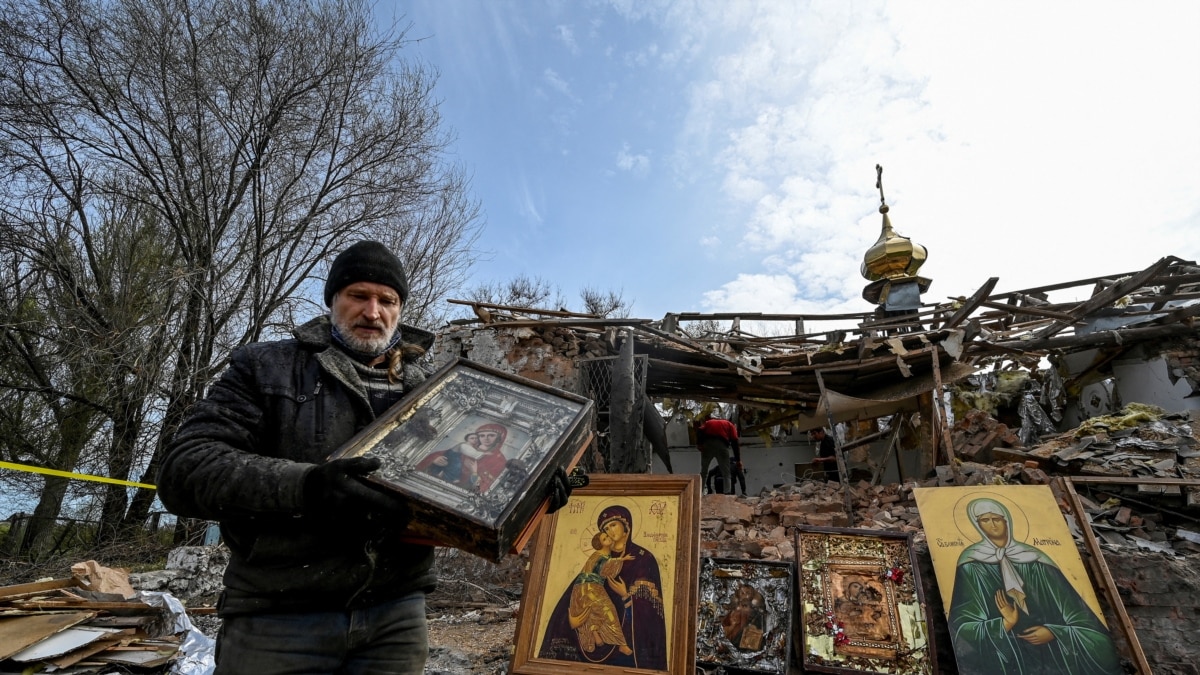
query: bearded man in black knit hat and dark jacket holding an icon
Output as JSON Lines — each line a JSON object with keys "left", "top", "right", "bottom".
{"left": 158, "top": 241, "right": 570, "bottom": 675}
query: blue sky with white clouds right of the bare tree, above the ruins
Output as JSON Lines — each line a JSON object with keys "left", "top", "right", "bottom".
{"left": 376, "top": 0, "right": 1200, "bottom": 318}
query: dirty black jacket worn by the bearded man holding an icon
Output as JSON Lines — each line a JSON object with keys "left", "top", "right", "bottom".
{"left": 158, "top": 317, "right": 436, "bottom": 616}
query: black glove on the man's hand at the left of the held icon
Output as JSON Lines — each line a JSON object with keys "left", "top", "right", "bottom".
{"left": 304, "top": 458, "right": 413, "bottom": 530}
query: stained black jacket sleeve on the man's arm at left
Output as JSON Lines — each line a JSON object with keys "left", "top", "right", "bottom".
{"left": 158, "top": 345, "right": 313, "bottom": 520}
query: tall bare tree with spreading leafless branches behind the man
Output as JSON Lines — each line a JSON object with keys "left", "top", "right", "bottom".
{"left": 0, "top": 0, "right": 478, "bottom": 540}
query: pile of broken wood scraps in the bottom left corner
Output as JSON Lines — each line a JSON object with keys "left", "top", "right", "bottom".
{"left": 0, "top": 578, "right": 180, "bottom": 674}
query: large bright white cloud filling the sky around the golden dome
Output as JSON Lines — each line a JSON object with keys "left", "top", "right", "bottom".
{"left": 662, "top": 1, "right": 1200, "bottom": 311}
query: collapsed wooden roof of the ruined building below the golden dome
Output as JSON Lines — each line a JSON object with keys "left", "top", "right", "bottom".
{"left": 451, "top": 257, "right": 1200, "bottom": 414}
